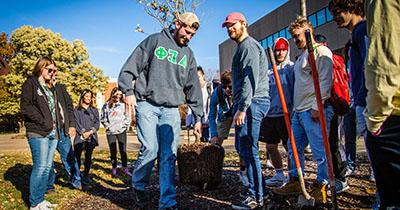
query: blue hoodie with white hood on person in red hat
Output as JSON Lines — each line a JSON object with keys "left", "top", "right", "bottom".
{"left": 267, "top": 37, "right": 294, "bottom": 117}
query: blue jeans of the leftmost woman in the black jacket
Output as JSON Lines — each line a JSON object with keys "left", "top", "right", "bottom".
{"left": 28, "top": 131, "right": 57, "bottom": 207}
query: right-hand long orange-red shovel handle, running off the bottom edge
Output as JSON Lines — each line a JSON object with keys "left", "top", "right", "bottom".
{"left": 304, "top": 30, "right": 338, "bottom": 209}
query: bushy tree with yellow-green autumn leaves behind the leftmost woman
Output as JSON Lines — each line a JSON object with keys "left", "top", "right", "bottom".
{"left": 0, "top": 26, "right": 107, "bottom": 128}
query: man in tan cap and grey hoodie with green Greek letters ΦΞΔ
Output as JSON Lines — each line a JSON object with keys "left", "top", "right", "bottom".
{"left": 118, "top": 12, "right": 203, "bottom": 209}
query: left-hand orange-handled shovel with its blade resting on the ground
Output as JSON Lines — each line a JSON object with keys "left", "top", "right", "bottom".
{"left": 268, "top": 47, "right": 315, "bottom": 207}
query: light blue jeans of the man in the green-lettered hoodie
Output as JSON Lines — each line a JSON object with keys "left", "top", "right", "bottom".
{"left": 132, "top": 101, "right": 181, "bottom": 209}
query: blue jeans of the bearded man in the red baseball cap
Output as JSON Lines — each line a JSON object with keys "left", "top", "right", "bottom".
{"left": 234, "top": 97, "right": 270, "bottom": 200}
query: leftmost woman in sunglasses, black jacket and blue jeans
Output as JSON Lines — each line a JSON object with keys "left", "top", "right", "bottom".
{"left": 20, "top": 57, "right": 61, "bottom": 210}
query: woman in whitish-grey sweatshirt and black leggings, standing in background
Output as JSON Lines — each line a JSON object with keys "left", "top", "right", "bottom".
{"left": 101, "top": 87, "right": 132, "bottom": 176}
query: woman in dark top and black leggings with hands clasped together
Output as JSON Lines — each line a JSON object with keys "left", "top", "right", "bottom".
{"left": 74, "top": 90, "right": 100, "bottom": 185}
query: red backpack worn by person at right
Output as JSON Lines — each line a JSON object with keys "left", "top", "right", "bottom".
{"left": 330, "top": 53, "right": 350, "bottom": 116}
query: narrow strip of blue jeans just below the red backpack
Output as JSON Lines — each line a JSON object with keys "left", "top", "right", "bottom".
{"left": 343, "top": 106, "right": 357, "bottom": 171}
